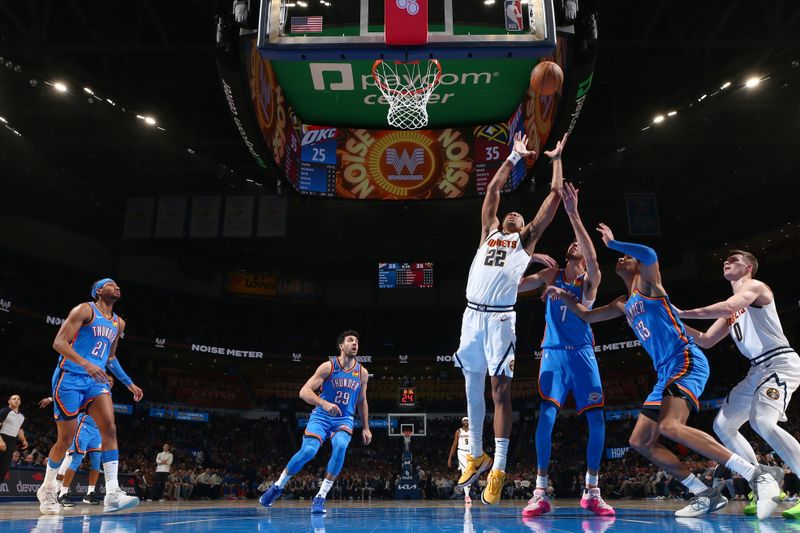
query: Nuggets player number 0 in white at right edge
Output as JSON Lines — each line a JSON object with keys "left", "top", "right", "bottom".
{"left": 678, "top": 250, "right": 800, "bottom": 518}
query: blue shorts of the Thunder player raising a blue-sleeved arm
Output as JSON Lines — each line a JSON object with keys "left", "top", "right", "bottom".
{"left": 642, "top": 345, "right": 709, "bottom": 411}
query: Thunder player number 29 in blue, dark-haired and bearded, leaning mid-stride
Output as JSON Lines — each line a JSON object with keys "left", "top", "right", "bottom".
{"left": 259, "top": 330, "right": 372, "bottom": 514}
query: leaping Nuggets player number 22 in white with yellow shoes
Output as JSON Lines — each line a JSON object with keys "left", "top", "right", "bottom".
{"left": 455, "top": 133, "right": 567, "bottom": 505}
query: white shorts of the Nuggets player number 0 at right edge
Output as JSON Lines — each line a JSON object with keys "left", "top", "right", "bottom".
{"left": 722, "top": 352, "right": 800, "bottom": 422}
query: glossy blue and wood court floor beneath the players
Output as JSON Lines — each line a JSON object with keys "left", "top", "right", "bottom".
{"left": 0, "top": 500, "right": 800, "bottom": 533}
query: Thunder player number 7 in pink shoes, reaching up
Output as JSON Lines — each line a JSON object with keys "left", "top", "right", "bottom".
{"left": 519, "top": 183, "right": 614, "bottom": 516}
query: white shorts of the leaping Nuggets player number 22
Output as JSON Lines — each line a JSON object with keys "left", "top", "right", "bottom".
{"left": 454, "top": 307, "right": 517, "bottom": 378}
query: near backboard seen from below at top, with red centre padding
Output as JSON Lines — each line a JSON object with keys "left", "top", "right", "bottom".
{"left": 258, "top": 0, "right": 556, "bottom": 61}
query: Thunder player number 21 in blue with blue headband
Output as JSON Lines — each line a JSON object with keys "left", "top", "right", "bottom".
{"left": 36, "top": 278, "right": 142, "bottom": 514}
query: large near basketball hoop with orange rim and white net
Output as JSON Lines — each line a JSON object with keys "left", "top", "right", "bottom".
{"left": 372, "top": 59, "right": 442, "bottom": 130}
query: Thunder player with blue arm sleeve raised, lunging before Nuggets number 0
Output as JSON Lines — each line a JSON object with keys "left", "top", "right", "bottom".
{"left": 545, "top": 224, "right": 783, "bottom": 518}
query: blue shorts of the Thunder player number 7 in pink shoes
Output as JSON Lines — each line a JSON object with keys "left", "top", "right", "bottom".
{"left": 539, "top": 346, "right": 605, "bottom": 414}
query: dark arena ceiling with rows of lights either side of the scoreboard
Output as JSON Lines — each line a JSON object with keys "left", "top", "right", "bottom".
{"left": 0, "top": 0, "right": 800, "bottom": 274}
